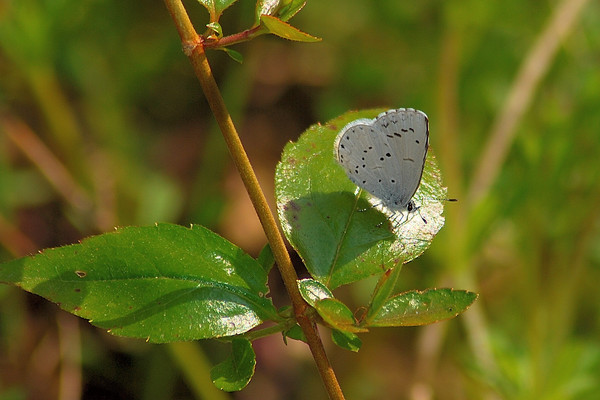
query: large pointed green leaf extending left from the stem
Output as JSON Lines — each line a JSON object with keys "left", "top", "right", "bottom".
{"left": 0, "top": 224, "right": 279, "bottom": 343}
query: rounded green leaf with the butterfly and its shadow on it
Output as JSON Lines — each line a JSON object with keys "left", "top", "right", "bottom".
{"left": 275, "top": 109, "right": 446, "bottom": 289}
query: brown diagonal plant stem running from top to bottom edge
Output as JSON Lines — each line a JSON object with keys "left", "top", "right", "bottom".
{"left": 165, "top": 0, "right": 344, "bottom": 399}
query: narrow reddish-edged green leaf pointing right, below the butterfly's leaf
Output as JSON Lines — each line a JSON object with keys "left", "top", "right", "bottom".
{"left": 363, "top": 289, "right": 477, "bottom": 327}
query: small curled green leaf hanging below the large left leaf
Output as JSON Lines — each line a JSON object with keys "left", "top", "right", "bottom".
{"left": 210, "top": 338, "right": 256, "bottom": 392}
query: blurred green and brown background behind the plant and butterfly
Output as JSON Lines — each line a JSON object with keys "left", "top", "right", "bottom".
{"left": 0, "top": 0, "right": 600, "bottom": 400}
